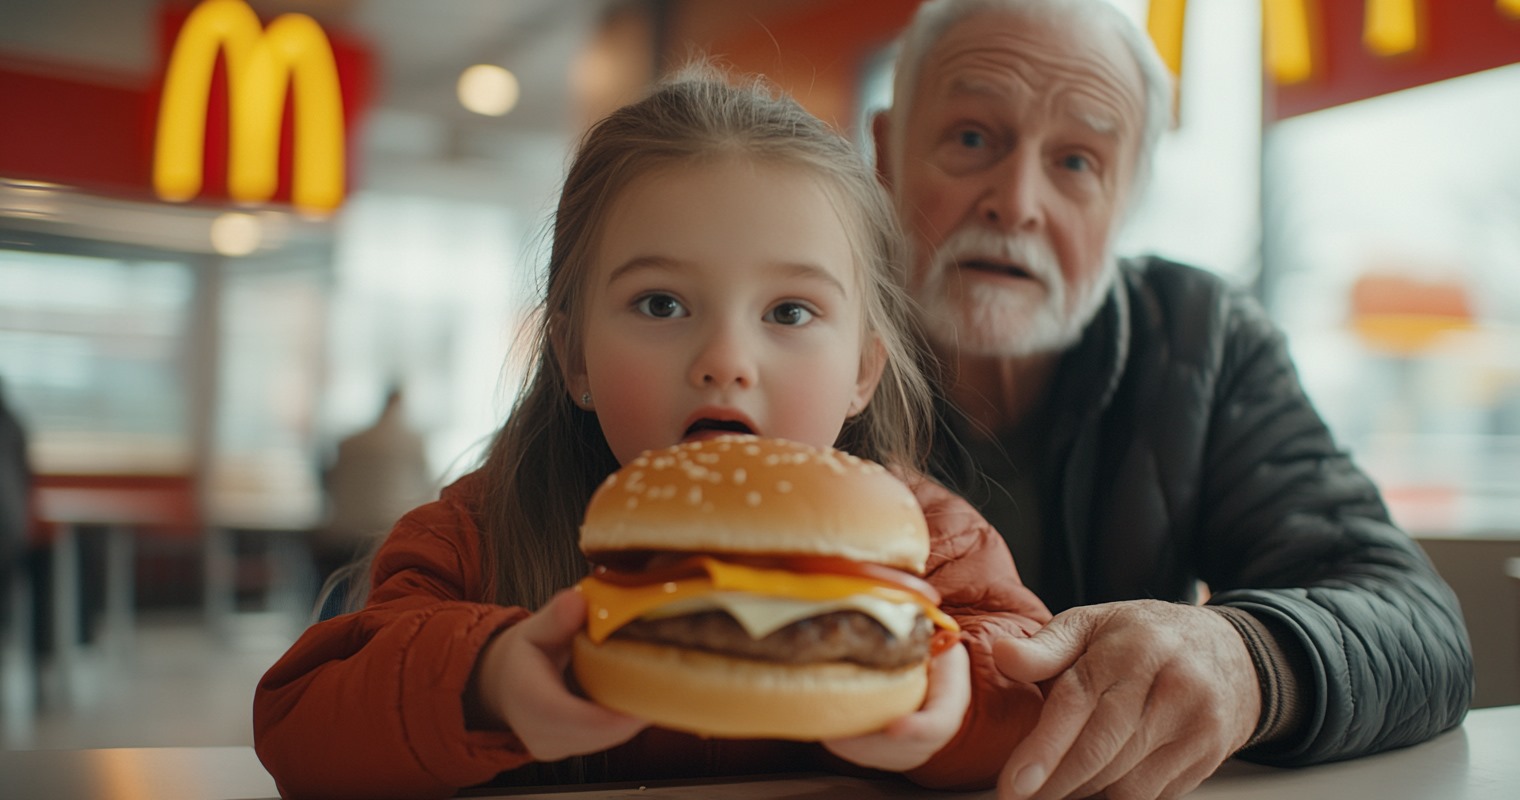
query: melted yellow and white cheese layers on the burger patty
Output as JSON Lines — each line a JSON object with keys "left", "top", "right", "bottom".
{"left": 579, "top": 558, "right": 961, "bottom": 642}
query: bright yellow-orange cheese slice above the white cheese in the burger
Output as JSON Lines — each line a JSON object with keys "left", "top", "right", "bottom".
{"left": 581, "top": 558, "right": 961, "bottom": 642}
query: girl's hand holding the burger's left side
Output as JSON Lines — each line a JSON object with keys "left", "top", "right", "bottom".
{"left": 476, "top": 590, "right": 649, "bottom": 760}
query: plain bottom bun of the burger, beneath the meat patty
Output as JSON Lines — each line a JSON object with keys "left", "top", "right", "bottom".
{"left": 575, "top": 634, "right": 929, "bottom": 742}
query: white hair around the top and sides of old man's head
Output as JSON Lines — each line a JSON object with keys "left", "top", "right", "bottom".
{"left": 889, "top": 0, "right": 1172, "bottom": 208}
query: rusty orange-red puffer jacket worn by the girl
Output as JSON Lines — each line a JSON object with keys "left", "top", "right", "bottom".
{"left": 254, "top": 473, "right": 1050, "bottom": 798}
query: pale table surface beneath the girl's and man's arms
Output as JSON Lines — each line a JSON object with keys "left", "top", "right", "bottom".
{"left": 0, "top": 706, "right": 1520, "bottom": 800}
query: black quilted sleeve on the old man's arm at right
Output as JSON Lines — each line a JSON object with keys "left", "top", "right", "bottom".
{"left": 1201, "top": 293, "right": 1473, "bottom": 765}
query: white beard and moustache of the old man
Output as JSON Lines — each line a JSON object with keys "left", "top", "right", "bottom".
{"left": 912, "top": 228, "right": 1117, "bottom": 357}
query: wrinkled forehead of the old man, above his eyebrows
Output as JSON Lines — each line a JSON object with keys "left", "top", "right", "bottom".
{"left": 914, "top": 11, "right": 1145, "bottom": 137}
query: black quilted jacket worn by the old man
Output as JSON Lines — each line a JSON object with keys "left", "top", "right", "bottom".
{"left": 936, "top": 259, "right": 1473, "bottom": 765}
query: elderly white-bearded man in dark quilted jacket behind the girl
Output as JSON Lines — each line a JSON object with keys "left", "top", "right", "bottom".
{"left": 874, "top": 0, "right": 1473, "bottom": 798}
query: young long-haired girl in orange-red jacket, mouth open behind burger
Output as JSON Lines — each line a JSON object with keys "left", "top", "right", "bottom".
{"left": 254, "top": 73, "right": 1050, "bottom": 797}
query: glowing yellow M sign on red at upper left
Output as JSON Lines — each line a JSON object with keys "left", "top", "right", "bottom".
{"left": 154, "top": 0, "right": 345, "bottom": 214}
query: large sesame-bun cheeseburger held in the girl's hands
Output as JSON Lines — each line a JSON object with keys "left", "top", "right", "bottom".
{"left": 572, "top": 435, "right": 959, "bottom": 741}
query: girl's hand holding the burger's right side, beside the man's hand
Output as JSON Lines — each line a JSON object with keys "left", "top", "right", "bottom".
{"left": 824, "top": 645, "right": 971, "bottom": 773}
